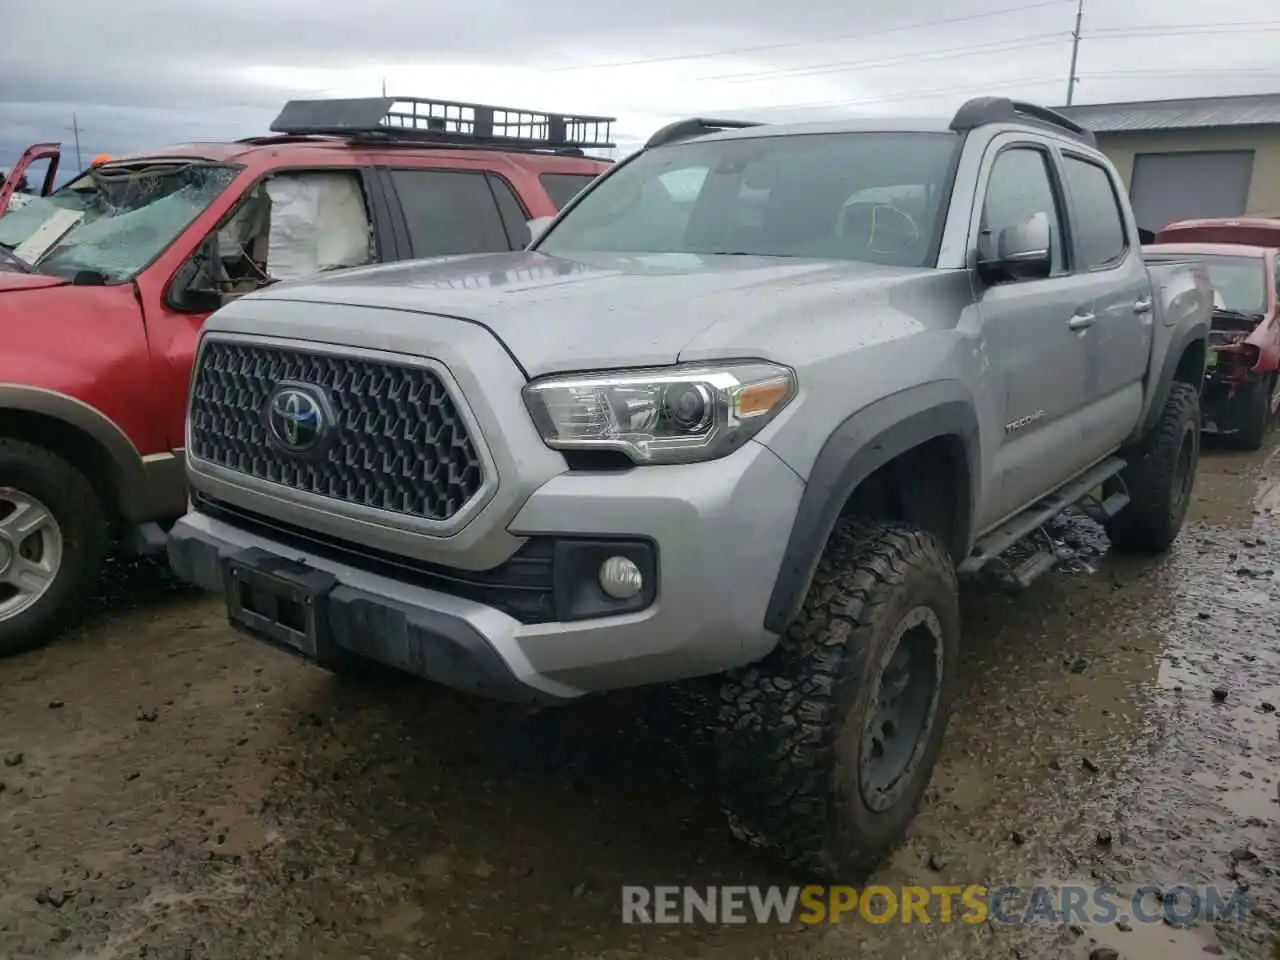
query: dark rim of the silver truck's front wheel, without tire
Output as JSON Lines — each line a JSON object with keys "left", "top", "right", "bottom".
{"left": 858, "top": 607, "right": 942, "bottom": 813}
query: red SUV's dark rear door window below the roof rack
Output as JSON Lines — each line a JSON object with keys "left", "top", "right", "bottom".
{"left": 389, "top": 170, "right": 511, "bottom": 257}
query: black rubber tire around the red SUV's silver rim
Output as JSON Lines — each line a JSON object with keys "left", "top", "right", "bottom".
{"left": 0, "top": 438, "right": 108, "bottom": 657}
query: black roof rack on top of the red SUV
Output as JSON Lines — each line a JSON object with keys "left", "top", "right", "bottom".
{"left": 263, "top": 97, "right": 614, "bottom": 154}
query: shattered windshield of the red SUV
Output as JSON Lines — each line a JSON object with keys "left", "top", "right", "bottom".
{"left": 0, "top": 160, "right": 239, "bottom": 283}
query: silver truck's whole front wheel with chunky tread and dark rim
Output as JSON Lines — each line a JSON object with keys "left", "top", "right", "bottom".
{"left": 718, "top": 521, "right": 960, "bottom": 877}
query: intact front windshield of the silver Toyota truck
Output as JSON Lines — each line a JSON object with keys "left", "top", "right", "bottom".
{"left": 536, "top": 133, "right": 960, "bottom": 266}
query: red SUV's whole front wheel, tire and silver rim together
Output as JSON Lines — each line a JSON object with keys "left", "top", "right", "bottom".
{"left": 0, "top": 439, "right": 106, "bottom": 657}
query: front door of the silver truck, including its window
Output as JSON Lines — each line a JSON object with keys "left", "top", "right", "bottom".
{"left": 970, "top": 134, "right": 1092, "bottom": 529}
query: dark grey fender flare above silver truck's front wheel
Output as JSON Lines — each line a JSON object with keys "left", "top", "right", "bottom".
{"left": 764, "top": 380, "right": 980, "bottom": 634}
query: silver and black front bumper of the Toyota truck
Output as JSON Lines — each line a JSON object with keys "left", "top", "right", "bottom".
{"left": 169, "top": 443, "right": 803, "bottom": 701}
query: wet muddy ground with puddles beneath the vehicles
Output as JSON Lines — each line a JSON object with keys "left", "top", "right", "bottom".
{"left": 0, "top": 440, "right": 1280, "bottom": 960}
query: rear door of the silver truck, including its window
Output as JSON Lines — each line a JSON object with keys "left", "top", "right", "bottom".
{"left": 1061, "top": 148, "right": 1155, "bottom": 460}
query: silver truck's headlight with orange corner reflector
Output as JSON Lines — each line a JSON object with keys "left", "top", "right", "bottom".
{"left": 525, "top": 360, "right": 796, "bottom": 463}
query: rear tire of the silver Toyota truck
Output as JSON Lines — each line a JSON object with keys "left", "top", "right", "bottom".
{"left": 1106, "top": 383, "right": 1201, "bottom": 553}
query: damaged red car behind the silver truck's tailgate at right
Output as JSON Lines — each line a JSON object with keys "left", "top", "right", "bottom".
{"left": 1143, "top": 218, "right": 1280, "bottom": 449}
